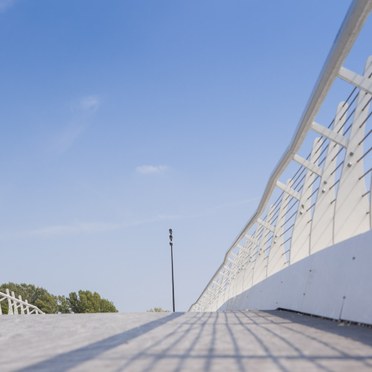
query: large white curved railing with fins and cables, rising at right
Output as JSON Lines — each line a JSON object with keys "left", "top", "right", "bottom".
{"left": 190, "top": 0, "right": 372, "bottom": 311}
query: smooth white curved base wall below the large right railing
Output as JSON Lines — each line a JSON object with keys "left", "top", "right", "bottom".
{"left": 219, "top": 231, "right": 372, "bottom": 324}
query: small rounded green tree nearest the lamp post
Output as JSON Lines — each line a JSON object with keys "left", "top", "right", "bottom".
{"left": 67, "top": 290, "right": 118, "bottom": 313}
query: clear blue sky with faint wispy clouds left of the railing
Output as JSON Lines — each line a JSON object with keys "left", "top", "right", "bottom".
{"left": 0, "top": 0, "right": 366, "bottom": 311}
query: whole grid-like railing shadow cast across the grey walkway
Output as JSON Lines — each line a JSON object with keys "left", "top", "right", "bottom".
{"left": 15, "top": 310, "right": 372, "bottom": 372}
